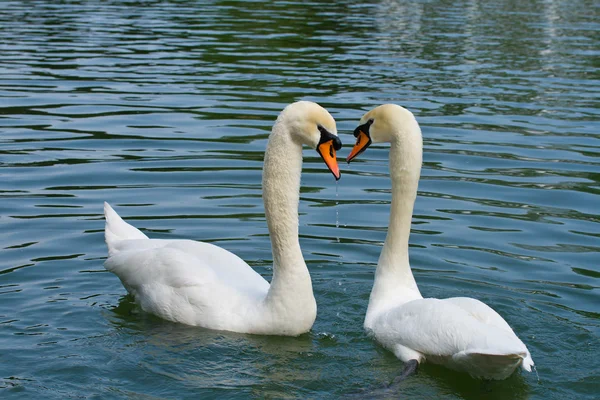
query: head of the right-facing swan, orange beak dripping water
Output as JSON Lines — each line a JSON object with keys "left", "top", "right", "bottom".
{"left": 281, "top": 101, "right": 342, "bottom": 180}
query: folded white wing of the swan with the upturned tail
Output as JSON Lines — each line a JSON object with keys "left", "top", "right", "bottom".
{"left": 105, "top": 239, "right": 269, "bottom": 330}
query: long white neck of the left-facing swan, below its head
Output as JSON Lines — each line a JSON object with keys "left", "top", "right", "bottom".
{"left": 365, "top": 121, "right": 423, "bottom": 328}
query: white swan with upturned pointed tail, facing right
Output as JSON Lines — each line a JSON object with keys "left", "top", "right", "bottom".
{"left": 104, "top": 101, "right": 341, "bottom": 336}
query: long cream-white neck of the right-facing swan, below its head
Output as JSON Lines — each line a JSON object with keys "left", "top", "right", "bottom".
{"left": 262, "top": 119, "right": 316, "bottom": 325}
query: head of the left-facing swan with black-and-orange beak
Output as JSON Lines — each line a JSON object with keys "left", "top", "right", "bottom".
{"left": 346, "top": 104, "right": 420, "bottom": 162}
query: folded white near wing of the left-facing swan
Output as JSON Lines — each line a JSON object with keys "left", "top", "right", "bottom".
{"left": 372, "top": 299, "right": 528, "bottom": 378}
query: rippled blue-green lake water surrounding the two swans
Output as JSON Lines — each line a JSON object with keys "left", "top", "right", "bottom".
{"left": 0, "top": 0, "right": 600, "bottom": 399}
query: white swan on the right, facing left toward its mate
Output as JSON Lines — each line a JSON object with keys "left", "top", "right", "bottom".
{"left": 347, "top": 104, "right": 533, "bottom": 379}
